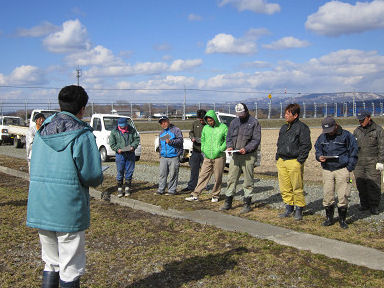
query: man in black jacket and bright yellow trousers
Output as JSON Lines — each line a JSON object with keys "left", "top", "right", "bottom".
{"left": 276, "top": 103, "right": 312, "bottom": 221}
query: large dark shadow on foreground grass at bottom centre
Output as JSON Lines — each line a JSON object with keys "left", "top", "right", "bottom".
{"left": 127, "top": 247, "right": 248, "bottom": 288}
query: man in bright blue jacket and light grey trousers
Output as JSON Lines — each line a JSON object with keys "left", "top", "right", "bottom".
{"left": 156, "top": 116, "right": 184, "bottom": 195}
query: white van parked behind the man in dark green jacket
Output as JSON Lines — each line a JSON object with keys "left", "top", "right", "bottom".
{"left": 90, "top": 114, "right": 141, "bottom": 162}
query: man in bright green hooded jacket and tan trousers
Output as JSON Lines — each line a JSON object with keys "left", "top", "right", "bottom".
{"left": 185, "top": 110, "right": 228, "bottom": 202}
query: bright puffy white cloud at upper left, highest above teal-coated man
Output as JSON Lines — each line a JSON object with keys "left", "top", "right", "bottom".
{"left": 43, "top": 19, "right": 91, "bottom": 53}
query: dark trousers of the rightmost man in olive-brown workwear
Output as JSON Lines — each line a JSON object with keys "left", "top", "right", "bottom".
{"left": 354, "top": 162, "right": 381, "bottom": 208}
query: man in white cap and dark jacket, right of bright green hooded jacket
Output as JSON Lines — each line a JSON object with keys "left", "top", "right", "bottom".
{"left": 221, "top": 103, "right": 261, "bottom": 213}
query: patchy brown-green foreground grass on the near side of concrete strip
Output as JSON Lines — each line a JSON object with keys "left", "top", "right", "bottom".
{"left": 0, "top": 170, "right": 384, "bottom": 288}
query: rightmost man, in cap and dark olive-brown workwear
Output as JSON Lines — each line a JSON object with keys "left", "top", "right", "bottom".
{"left": 353, "top": 110, "right": 384, "bottom": 215}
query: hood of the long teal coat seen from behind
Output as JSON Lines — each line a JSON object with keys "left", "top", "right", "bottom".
{"left": 36, "top": 112, "right": 92, "bottom": 152}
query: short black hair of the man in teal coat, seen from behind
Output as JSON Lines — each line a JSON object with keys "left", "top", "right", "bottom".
{"left": 59, "top": 85, "right": 88, "bottom": 115}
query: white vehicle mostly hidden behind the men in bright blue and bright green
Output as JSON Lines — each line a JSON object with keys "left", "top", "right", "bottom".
{"left": 155, "top": 112, "right": 261, "bottom": 167}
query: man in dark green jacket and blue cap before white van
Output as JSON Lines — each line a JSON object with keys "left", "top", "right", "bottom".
{"left": 109, "top": 117, "right": 140, "bottom": 197}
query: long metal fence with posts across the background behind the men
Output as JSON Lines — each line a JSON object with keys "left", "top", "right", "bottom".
{"left": 0, "top": 99, "right": 384, "bottom": 119}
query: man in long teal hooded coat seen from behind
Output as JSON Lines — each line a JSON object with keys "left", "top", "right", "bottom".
{"left": 27, "top": 85, "right": 103, "bottom": 287}
